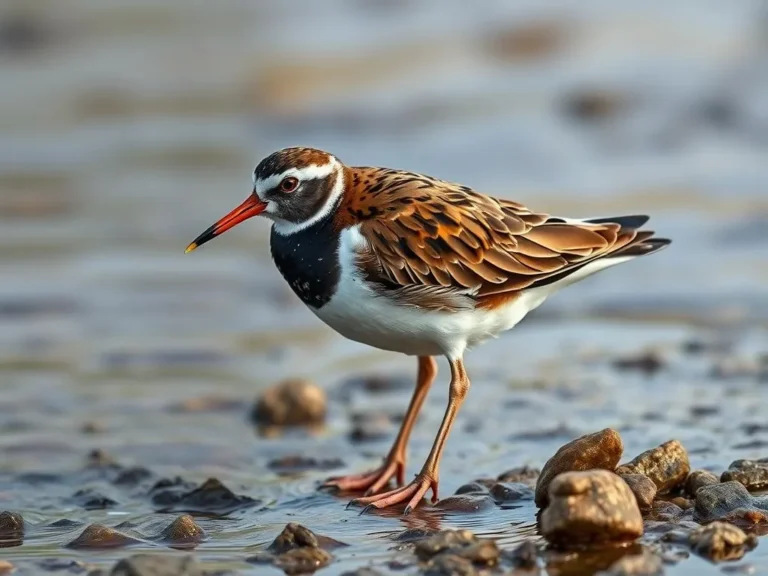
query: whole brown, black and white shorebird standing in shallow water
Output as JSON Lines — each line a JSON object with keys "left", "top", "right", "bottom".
{"left": 187, "top": 148, "right": 670, "bottom": 513}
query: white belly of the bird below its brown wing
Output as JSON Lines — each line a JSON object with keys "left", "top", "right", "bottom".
{"left": 310, "top": 224, "right": 547, "bottom": 358}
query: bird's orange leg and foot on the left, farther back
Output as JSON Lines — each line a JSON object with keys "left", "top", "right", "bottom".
{"left": 322, "top": 356, "right": 437, "bottom": 495}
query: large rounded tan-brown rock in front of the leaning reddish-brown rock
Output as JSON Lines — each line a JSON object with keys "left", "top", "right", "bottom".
{"left": 541, "top": 470, "right": 643, "bottom": 547}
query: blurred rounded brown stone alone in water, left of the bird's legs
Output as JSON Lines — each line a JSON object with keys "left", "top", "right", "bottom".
{"left": 251, "top": 379, "right": 326, "bottom": 426}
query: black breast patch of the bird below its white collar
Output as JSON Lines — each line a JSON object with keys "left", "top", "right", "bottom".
{"left": 269, "top": 215, "right": 341, "bottom": 309}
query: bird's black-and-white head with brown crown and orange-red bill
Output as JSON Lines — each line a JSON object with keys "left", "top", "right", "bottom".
{"left": 187, "top": 148, "right": 344, "bottom": 252}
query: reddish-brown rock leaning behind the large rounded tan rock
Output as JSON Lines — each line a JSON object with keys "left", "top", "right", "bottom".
{"left": 535, "top": 428, "right": 624, "bottom": 508}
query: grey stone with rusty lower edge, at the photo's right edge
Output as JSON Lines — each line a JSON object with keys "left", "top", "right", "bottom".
{"left": 694, "top": 482, "right": 768, "bottom": 524}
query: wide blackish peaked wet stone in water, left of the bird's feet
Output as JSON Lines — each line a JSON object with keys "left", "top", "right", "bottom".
{"left": 152, "top": 478, "right": 259, "bottom": 514}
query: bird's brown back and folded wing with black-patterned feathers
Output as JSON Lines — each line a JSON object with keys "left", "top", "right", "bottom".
{"left": 337, "top": 168, "right": 648, "bottom": 309}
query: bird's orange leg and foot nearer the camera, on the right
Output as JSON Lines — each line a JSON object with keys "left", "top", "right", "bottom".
{"left": 352, "top": 360, "right": 469, "bottom": 514}
